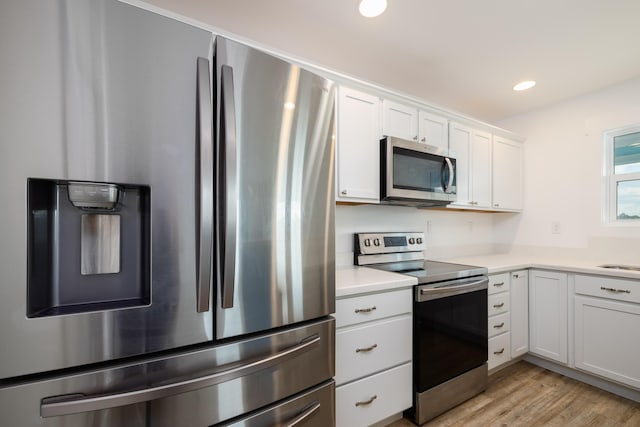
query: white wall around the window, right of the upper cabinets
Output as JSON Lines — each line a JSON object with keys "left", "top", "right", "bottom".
{"left": 494, "top": 79, "right": 640, "bottom": 263}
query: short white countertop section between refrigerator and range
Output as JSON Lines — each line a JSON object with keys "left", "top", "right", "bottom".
{"left": 336, "top": 265, "right": 418, "bottom": 298}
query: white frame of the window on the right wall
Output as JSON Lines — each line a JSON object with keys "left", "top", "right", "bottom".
{"left": 602, "top": 123, "right": 640, "bottom": 227}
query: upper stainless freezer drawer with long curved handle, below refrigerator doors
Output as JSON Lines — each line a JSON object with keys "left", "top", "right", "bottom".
{"left": 0, "top": 318, "right": 335, "bottom": 427}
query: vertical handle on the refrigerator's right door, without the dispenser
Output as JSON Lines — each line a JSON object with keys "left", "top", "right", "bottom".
{"left": 218, "top": 65, "right": 238, "bottom": 308}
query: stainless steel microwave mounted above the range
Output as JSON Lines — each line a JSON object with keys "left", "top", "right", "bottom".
{"left": 380, "top": 137, "right": 456, "bottom": 207}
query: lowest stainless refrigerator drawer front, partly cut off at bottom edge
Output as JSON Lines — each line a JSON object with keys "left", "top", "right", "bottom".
{"left": 215, "top": 381, "right": 335, "bottom": 427}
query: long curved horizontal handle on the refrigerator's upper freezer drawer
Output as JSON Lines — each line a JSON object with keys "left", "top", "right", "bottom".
{"left": 40, "top": 334, "right": 320, "bottom": 418}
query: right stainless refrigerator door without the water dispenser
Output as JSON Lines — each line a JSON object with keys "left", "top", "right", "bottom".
{"left": 214, "top": 37, "right": 335, "bottom": 338}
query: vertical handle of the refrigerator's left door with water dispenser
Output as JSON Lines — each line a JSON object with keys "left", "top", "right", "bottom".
{"left": 196, "top": 58, "right": 213, "bottom": 313}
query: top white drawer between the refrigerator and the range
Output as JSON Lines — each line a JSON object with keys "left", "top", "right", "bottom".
{"left": 334, "top": 288, "right": 413, "bottom": 328}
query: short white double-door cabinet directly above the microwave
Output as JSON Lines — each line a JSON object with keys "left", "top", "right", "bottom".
{"left": 382, "top": 99, "right": 449, "bottom": 150}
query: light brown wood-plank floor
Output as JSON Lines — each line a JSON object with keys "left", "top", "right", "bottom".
{"left": 388, "top": 362, "right": 640, "bottom": 427}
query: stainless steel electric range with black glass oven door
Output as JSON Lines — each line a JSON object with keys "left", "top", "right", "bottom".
{"left": 354, "top": 232, "right": 489, "bottom": 424}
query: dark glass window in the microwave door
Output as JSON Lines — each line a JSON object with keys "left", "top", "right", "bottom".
{"left": 393, "top": 147, "right": 442, "bottom": 193}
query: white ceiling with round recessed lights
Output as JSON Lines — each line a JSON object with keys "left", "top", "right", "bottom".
{"left": 145, "top": 0, "right": 640, "bottom": 122}
